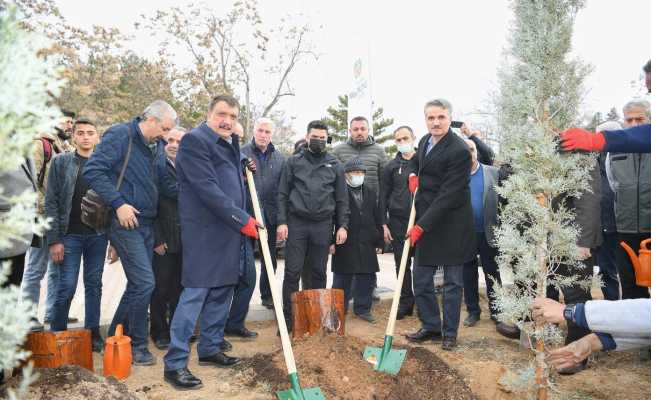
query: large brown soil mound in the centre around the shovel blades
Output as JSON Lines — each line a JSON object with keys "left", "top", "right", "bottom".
{"left": 242, "top": 335, "right": 476, "bottom": 400}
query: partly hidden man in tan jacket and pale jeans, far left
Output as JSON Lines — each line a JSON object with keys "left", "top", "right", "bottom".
{"left": 21, "top": 110, "right": 76, "bottom": 331}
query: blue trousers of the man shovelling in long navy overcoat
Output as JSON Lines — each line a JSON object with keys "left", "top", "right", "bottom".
{"left": 164, "top": 286, "right": 235, "bottom": 371}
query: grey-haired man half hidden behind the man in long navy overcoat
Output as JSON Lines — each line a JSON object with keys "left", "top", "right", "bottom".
{"left": 242, "top": 118, "right": 285, "bottom": 309}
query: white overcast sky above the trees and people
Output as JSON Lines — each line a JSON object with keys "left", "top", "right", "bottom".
{"left": 58, "top": 0, "right": 651, "bottom": 141}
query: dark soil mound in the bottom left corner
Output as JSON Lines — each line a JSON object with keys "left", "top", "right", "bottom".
{"left": 6, "top": 366, "right": 137, "bottom": 400}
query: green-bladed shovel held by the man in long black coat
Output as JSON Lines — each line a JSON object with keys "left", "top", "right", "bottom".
{"left": 364, "top": 193, "right": 416, "bottom": 375}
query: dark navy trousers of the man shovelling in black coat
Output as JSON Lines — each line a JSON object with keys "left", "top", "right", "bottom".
{"left": 414, "top": 265, "right": 463, "bottom": 339}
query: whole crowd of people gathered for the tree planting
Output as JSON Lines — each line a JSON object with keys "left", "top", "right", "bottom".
{"left": 0, "top": 61, "right": 651, "bottom": 389}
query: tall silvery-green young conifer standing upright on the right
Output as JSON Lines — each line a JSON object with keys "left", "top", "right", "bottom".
{"left": 496, "top": 0, "right": 595, "bottom": 399}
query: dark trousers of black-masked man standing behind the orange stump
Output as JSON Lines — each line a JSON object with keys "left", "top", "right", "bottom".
{"left": 283, "top": 216, "right": 332, "bottom": 327}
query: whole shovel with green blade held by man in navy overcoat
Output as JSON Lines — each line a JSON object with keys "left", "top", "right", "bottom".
{"left": 245, "top": 164, "right": 325, "bottom": 400}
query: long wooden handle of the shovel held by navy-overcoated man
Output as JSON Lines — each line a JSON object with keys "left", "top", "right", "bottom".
{"left": 244, "top": 167, "right": 296, "bottom": 375}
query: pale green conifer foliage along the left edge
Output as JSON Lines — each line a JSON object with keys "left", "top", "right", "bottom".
{"left": 0, "top": 4, "right": 63, "bottom": 399}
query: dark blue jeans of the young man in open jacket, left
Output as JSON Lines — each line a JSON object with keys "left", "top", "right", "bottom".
{"left": 52, "top": 234, "right": 108, "bottom": 331}
